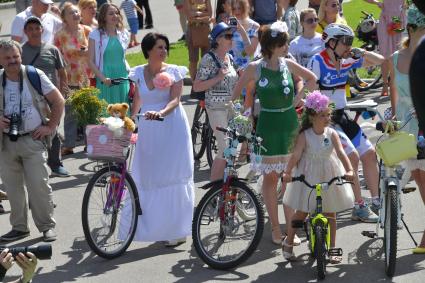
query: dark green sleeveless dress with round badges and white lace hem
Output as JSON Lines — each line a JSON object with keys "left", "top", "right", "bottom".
{"left": 256, "top": 59, "right": 298, "bottom": 174}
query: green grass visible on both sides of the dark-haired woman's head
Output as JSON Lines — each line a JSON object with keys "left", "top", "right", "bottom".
{"left": 126, "top": 41, "right": 189, "bottom": 67}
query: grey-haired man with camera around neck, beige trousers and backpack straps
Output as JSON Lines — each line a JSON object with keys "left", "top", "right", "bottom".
{"left": 0, "top": 40, "right": 65, "bottom": 241}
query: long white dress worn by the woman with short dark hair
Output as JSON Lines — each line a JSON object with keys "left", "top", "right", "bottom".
{"left": 124, "top": 65, "right": 194, "bottom": 242}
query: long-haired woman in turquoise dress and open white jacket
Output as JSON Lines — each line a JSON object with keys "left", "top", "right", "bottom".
{"left": 89, "top": 3, "right": 129, "bottom": 103}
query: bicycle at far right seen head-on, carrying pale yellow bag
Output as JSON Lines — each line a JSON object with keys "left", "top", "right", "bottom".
{"left": 347, "top": 101, "right": 417, "bottom": 277}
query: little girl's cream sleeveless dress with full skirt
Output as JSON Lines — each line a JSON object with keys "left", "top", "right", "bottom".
{"left": 283, "top": 127, "right": 354, "bottom": 212}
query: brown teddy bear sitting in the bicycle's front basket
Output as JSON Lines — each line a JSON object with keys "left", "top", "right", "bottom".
{"left": 101, "top": 103, "right": 136, "bottom": 132}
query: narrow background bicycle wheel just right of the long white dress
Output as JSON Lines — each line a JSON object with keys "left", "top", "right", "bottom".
{"left": 191, "top": 104, "right": 209, "bottom": 160}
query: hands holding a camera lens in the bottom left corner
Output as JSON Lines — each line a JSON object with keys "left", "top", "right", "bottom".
{"left": 0, "top": 248, "right": 37, "bottom": 283}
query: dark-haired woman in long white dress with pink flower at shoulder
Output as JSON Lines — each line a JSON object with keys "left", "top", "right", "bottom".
{"left": 129, "top": 33, "right": 194, "bottom": 246}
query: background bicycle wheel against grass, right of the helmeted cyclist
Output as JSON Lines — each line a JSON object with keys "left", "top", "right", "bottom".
{"left": 353, "top": 66, "right": 382, "bottom": 91}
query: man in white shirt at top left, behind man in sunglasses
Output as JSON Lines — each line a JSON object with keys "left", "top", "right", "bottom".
{"left": 10, "top": 0, "right": 62, "bottom": 44}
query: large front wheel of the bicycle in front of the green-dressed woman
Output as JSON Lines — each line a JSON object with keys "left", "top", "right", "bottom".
{"left": 192, "top": 180, "right": 264, "bottom": 269}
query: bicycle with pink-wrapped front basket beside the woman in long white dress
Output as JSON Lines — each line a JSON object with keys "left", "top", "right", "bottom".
{"left": 81, "top": 114, "right": 163, "bottom": 259}
